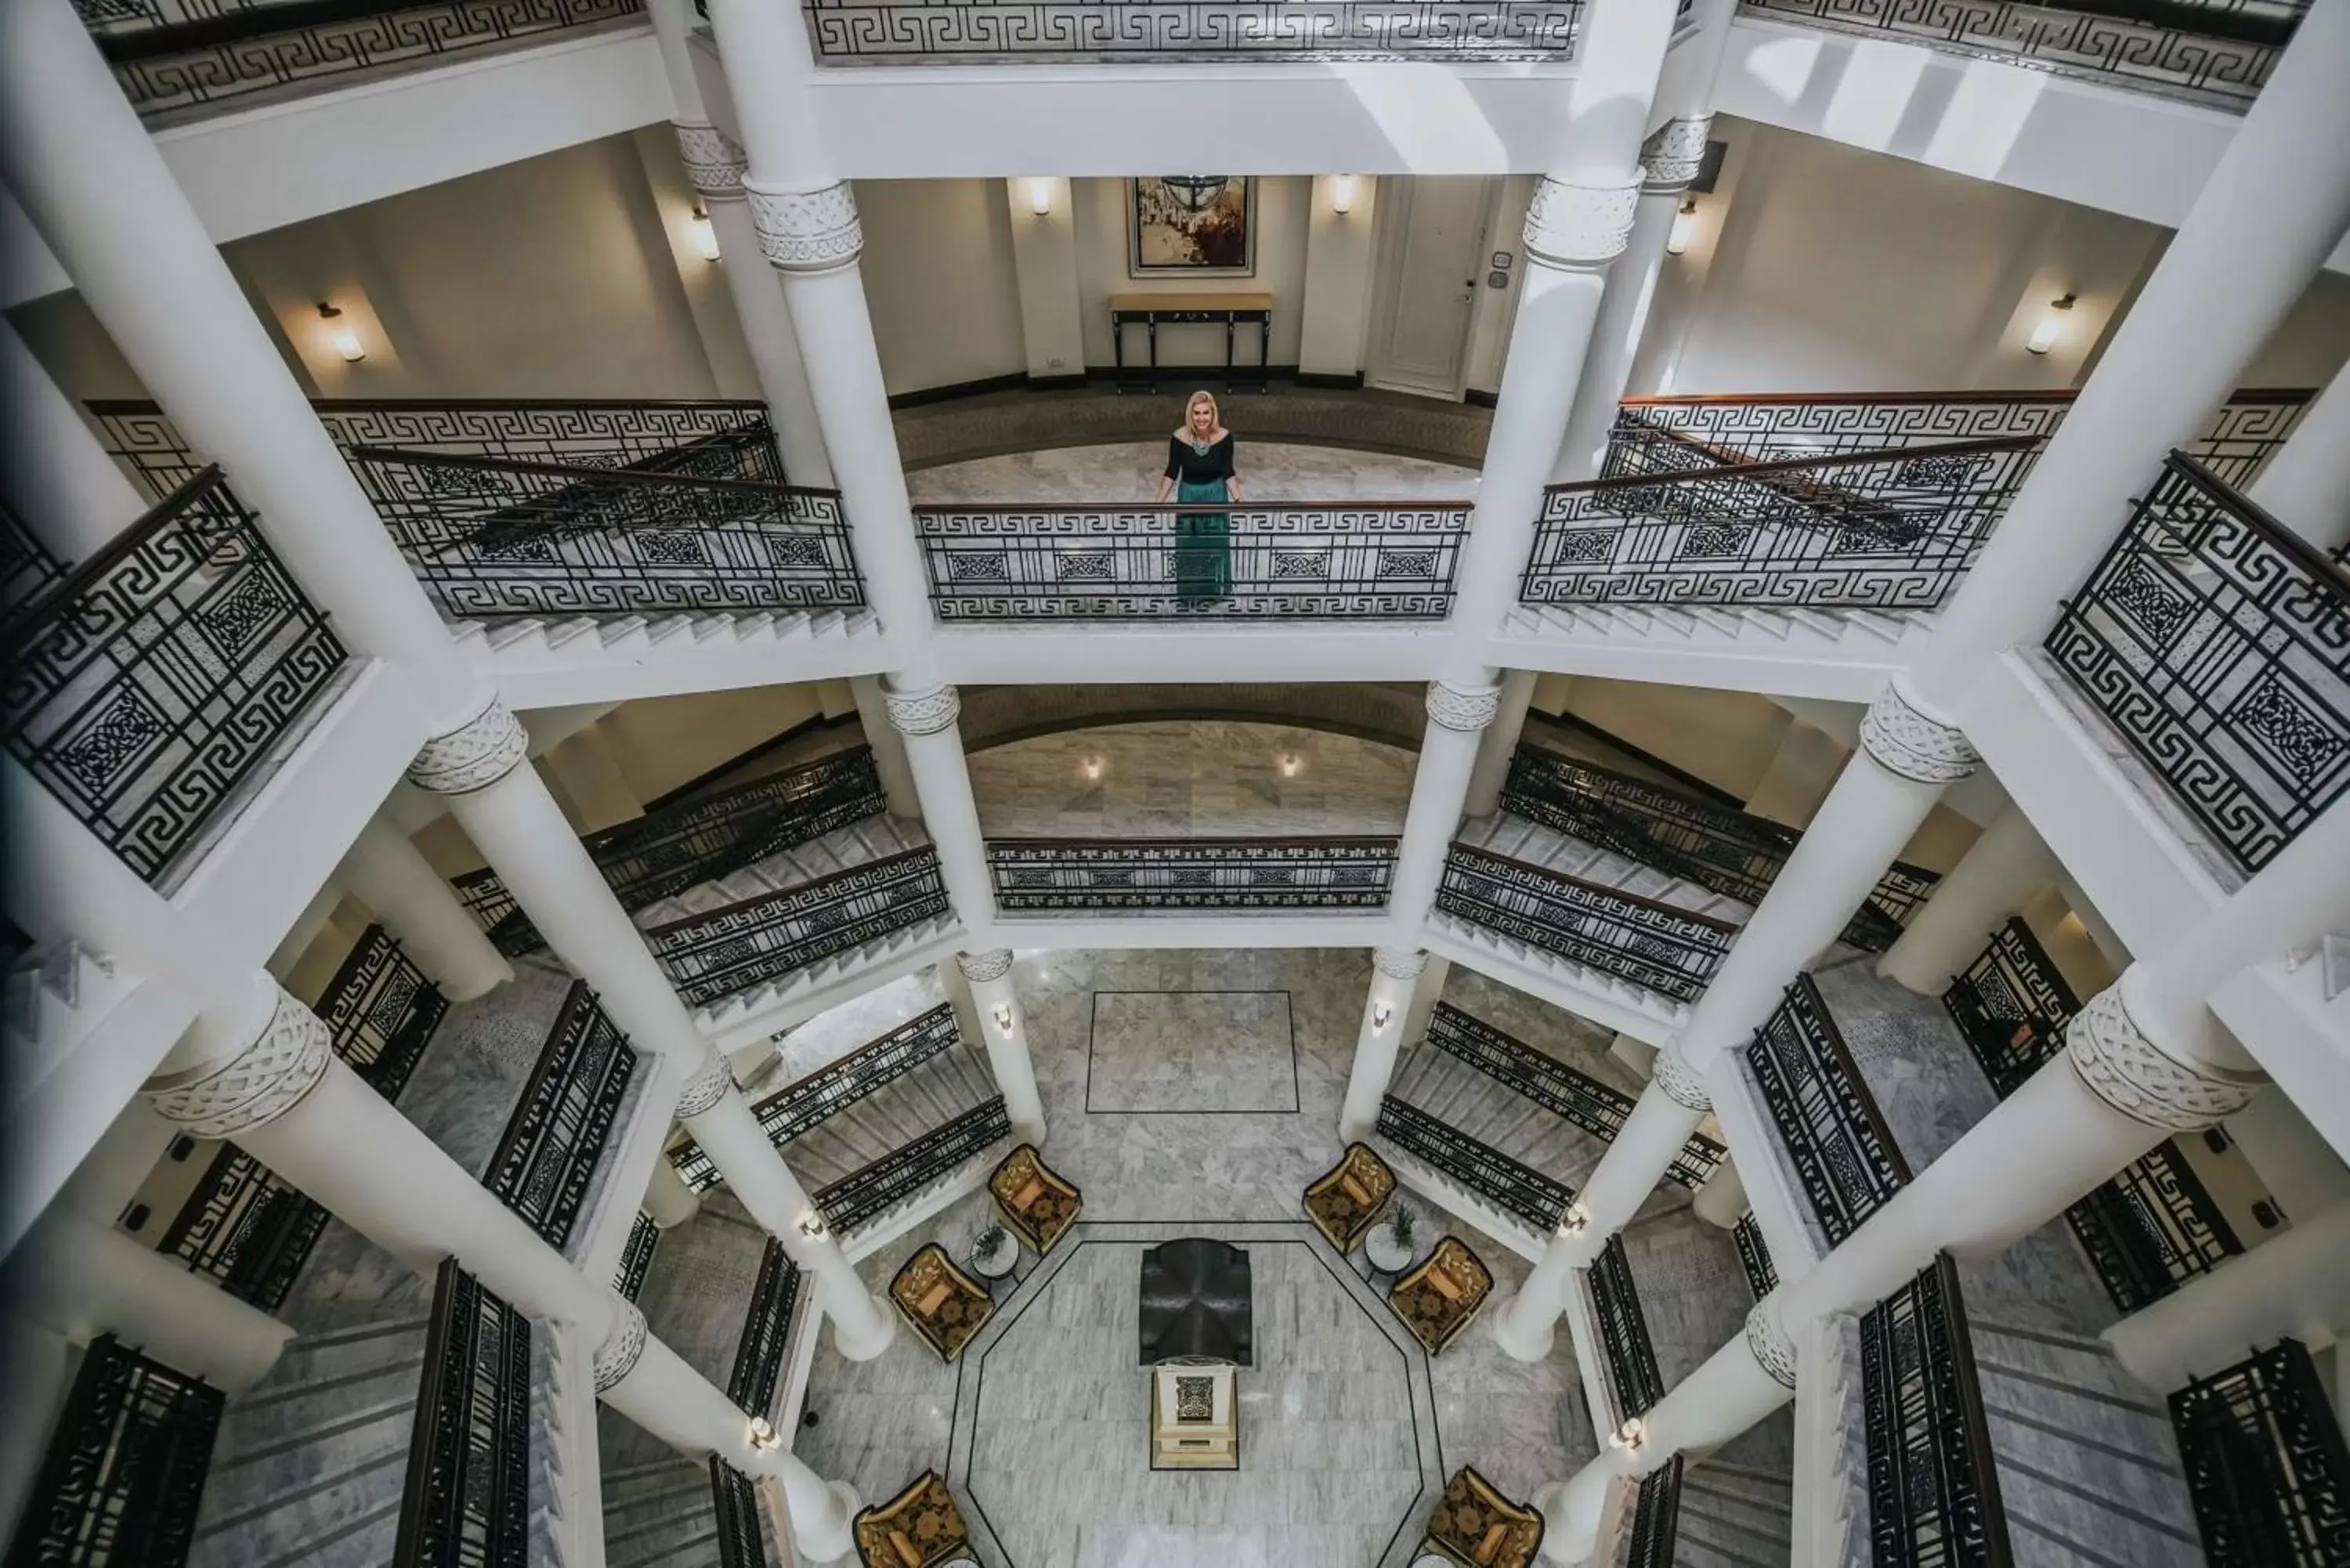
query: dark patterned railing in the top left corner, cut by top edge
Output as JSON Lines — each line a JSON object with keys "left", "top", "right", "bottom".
{"left": 73, "top": 0, "right": 644, "bottom": 115}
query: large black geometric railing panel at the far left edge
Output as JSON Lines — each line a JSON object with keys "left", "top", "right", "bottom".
{"left": 0, "top": 468, "right": 343, "bottom": 884}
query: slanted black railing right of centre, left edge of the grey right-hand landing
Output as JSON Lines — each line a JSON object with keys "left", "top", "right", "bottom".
{"left": 1746, "top": 974, "right": 1911, "bottom": 1246}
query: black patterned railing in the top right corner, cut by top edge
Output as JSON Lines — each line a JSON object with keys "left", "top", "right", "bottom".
{"left": 1739, "top": 0, "right": 2308, "bottom": 110}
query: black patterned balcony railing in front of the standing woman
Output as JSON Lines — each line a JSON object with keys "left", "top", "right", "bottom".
{"left": 914, "top": 505, "right": 1469, "bottom": 620}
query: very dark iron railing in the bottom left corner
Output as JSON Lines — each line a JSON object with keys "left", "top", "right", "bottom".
{"left": 7, "top": 1333, "right": 223, "bottom": 1568}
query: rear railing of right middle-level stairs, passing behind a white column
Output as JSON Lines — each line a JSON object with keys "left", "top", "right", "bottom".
{"left": 1502, "top": 745, "right": 1941, "bottom": 952}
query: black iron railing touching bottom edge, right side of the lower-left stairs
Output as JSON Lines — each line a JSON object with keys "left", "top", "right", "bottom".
{"left": 392, "top": 1258, "right": 531, "bottom": 1568}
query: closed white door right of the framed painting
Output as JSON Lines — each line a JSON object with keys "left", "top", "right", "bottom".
{"left": 1368, "top": 174, "right": 1492, "bottom": 397}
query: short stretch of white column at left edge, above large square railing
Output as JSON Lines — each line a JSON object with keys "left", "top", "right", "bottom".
{"left": 0, "top": 320, "right": 148, "bottom": 564}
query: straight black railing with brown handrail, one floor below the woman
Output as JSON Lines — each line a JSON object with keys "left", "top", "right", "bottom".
{"left": 987, "top": 837, "right": 1396, "bottom": 915}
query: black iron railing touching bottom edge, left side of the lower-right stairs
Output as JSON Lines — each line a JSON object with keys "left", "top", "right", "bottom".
{"left": 1861, "top": 1253, "right": 2009, "bottom": 1568}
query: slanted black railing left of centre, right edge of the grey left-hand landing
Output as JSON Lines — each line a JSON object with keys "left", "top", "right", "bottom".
{"left": 482, "top": 981, "right": 637, "bottom": 1248}
